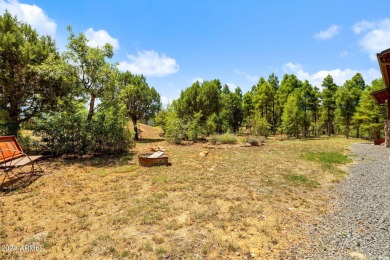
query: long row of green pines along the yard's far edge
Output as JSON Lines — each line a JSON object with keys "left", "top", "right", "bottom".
{"left": 156, "top": 73, "right": 386, "bottom": 141}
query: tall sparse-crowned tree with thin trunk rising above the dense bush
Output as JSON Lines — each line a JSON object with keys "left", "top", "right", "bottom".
{"left": 65, "top": 26, "right": 115, "bottom": 121}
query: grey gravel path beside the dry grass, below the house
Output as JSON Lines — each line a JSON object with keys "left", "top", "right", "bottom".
{"left": 292, "top": 144, "right": 390, "bottom": 259}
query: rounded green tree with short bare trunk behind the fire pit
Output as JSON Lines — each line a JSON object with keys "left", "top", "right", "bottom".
{"left": 120, "top": 75, "right": 161, "bottom": 140}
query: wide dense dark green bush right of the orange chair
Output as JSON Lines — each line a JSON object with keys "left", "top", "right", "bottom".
{"left": 34, "top": 101, "right": 133, "bottom": 155}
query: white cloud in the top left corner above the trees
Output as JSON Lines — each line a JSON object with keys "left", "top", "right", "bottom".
{"left": 0, "top": 0, "right": 57, "bottom": 37}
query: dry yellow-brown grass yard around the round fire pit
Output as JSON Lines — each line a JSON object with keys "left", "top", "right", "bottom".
{"left": 0, "top": 127, "right": 357, "bottom": 259}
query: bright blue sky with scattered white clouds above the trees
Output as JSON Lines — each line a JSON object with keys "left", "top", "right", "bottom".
{"left": 0, "top": 0, "right": 390, "bottom": 103}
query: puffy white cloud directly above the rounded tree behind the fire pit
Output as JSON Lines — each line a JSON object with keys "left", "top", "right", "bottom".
{"left": 118, "top": 50, "right": 179, "bottom": 76}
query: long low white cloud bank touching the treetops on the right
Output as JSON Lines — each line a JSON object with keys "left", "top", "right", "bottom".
{"left": 283, "top": 62, "right": 381, "bottom": 88}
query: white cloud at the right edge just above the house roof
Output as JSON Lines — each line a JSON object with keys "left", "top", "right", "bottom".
{"left": 353, "top": 18, "right": 390, "bottom": 61}
